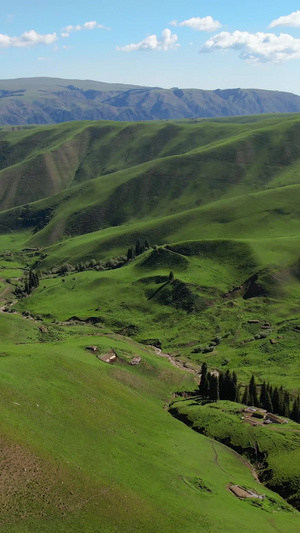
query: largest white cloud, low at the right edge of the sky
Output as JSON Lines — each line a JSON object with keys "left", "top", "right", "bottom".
{"left": 200, "top": 31, "right": 300, "bottom": 63}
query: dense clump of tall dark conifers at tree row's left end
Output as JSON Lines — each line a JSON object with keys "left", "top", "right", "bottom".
{"left": 199, "top": 363, "right": 239, "bottom": 402}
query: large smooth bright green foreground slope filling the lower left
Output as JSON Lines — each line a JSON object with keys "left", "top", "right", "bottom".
{"left": 0, "top": 316, "right": 299, "bottom": 533}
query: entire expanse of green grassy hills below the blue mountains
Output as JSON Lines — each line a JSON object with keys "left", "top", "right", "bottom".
{"left": 0, "top": 115, "right": 300, "bottom": 533}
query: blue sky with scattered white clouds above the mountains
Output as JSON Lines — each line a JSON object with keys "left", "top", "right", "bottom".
{"left": 0, "top": 0, "right": 300, "bottom": 94}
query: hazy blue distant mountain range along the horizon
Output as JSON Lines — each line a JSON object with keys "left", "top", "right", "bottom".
{"left": 0, "top": 78, "right": 300, "bottom": 125}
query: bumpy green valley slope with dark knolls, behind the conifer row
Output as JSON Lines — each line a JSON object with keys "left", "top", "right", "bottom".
{"left": 7, "top": 239, "right": 300, "bottom": 394}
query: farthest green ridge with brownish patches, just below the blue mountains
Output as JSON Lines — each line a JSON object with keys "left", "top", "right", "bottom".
{"left": 0, "top": 115, "right": 299, "bottom": 212}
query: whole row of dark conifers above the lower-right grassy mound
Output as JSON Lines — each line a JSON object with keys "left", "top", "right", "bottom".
{"left": 199, "top": 363, "right": 300, "bottom": 423}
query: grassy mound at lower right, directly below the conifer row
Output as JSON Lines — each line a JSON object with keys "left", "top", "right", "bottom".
{"left": 171, "top": 400, "right": 300, "bottom": 508}
